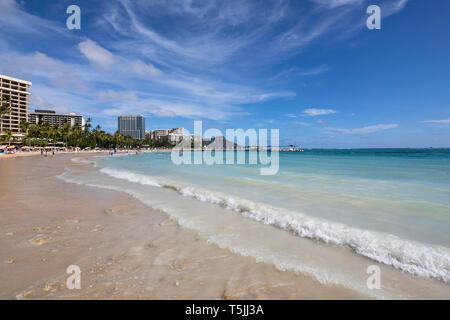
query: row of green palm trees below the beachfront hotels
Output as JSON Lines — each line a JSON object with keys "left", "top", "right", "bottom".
{"left": 1, "top": 118, "right": 171, "bottom": 149}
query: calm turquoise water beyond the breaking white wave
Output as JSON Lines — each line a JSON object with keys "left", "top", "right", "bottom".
{"left": 102, "top": 149, "right": 450, "bottom": 247}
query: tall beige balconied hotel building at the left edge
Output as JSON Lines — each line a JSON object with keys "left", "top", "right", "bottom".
{"left": 0, "top": 74, "right": 31, "bottom": 134}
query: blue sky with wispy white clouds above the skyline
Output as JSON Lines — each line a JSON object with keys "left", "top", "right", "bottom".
{"left": 0, "top": 0, "right": 450, "bottom": 148}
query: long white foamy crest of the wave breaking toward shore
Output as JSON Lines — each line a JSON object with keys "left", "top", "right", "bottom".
{"left": 100, "top": 168, "right": 450, "bottom": 283}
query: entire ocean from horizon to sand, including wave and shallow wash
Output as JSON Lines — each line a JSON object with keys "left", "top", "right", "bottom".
{"left": 62, "top": 149, "right": 450, "bottom": 298}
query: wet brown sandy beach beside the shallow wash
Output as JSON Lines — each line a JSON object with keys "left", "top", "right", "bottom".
{"left": 0, "top": 154, "right": 366, "bottom": 299}
